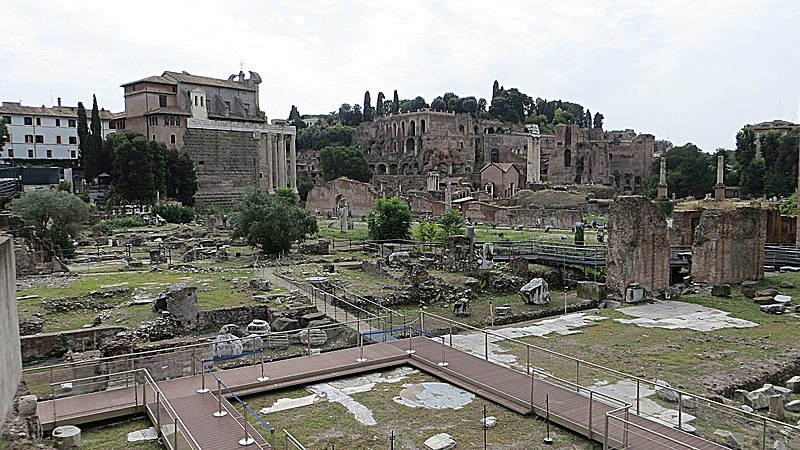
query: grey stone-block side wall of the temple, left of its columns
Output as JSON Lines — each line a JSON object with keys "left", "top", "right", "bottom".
{"left": 182, "top": 128, "right": 258, "bottom": 206}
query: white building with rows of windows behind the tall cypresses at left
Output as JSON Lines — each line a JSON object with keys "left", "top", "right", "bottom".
{"left": 0, "top": 98, "right": 116, "bottom": 160}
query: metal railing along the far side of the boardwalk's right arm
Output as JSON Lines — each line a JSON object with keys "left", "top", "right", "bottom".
{"left": 419, "top": 311, "right": 800, "bottom": 449}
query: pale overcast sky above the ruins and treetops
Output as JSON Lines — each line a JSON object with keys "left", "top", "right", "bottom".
{"left": 0, "top": 0, "right": 800, "bottom": 151}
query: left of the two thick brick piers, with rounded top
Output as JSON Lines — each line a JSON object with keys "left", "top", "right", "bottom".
{"left": 606, "top": 196, "right": 669, "bottom": 296}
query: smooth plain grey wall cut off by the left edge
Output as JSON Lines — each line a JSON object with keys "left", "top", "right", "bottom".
{"left": 0, "top": 236, "right": 22, "bottom": 419}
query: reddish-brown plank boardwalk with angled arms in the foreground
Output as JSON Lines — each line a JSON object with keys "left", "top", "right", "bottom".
{"left": 38, "top": 337, "right": 726, "bottom": 450}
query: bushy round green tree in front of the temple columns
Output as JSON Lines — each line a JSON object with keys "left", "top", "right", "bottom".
{"left": 233, "top": 188, "right": 317, "bottom": 255}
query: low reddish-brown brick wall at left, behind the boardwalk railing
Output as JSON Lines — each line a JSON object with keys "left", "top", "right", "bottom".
{"left": 19, "top": 327, "right": 126, "bottom": 363}
